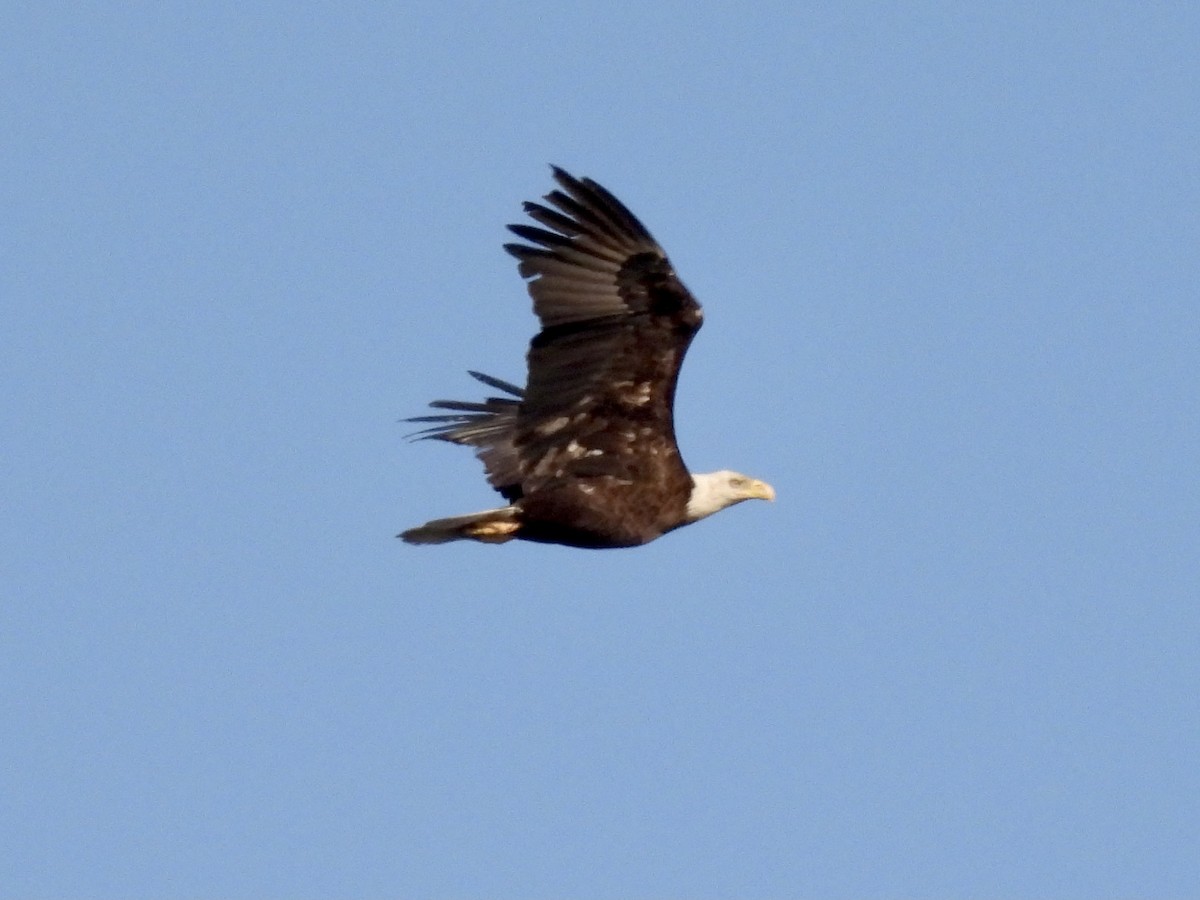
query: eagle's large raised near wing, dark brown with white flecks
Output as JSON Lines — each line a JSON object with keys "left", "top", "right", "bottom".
{"left": 505, "top": 168, "right": 702, "bottom": 496}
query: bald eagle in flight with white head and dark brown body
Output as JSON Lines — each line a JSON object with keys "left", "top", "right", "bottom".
{"left": 398, "top": 167, "right": 775, "bottom": 548}
